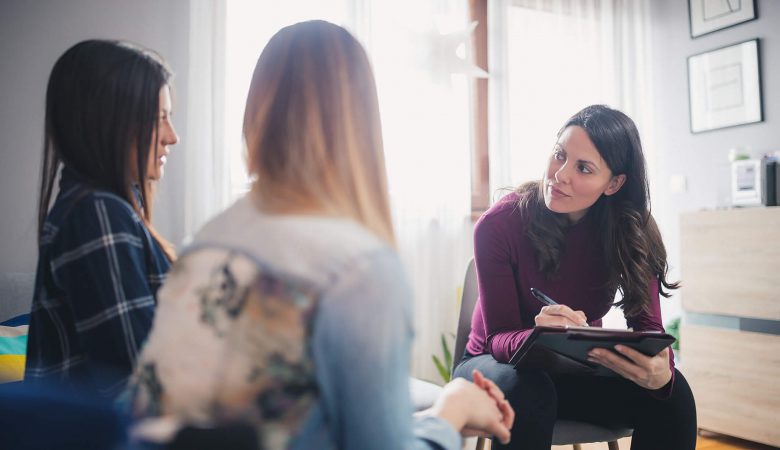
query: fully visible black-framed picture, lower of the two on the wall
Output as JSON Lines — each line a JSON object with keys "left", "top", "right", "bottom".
{"left": 688, "top": 39, "right": 764, "bottom": 133}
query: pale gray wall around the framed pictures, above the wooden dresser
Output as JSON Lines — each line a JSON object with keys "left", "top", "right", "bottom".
{"left": 651, "top": 0, "right": 780, "bottom": 319}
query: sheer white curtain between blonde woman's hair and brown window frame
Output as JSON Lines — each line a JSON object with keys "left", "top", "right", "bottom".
{"left": 348, "top": 0, "right": 479, "bottom": 381}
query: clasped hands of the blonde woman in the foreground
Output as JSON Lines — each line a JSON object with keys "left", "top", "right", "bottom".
{"left": 429, "top": 378, "right": 514, "bottom": 444}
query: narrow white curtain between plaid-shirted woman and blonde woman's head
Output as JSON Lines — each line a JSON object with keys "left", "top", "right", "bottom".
{"left": 182, "top": 0, "right": 230, "bottom": 241}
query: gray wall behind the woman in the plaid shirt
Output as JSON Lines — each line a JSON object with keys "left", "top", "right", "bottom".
{"left": 0, "top": 0, "right": 189, "bottom": 278}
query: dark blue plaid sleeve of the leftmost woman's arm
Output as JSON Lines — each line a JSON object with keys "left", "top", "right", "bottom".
{"left": 51, "top": 196, "right": 162, "bottom": 396}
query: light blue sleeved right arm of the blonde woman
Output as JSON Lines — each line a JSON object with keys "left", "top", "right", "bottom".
{"left": 313, "top": 250, "right": 461, "bottom": 450}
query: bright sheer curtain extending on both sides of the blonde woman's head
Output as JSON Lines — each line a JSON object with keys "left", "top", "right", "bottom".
{"left": 186, "top": 0, "right": 479, "bottom": 381}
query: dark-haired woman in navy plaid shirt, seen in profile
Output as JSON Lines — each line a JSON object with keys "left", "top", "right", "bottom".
{"left": 25, "top": 40, "right": 178, "bottom": 397}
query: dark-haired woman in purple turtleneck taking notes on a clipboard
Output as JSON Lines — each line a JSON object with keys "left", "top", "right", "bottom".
{"left": 455, "top": 105, "right": 696, "bottom": 450}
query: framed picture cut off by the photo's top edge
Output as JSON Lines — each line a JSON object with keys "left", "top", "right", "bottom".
{"left": 688, "top": 0, "right": 757, "bottom": 38}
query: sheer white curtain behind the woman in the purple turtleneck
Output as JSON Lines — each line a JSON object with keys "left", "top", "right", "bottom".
{"left": 488, "top": 0, "right": 654, "bottom": 327}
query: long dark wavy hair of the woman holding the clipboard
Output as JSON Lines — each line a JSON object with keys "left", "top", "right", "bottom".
{"left": 517, "top": 105, "right": 679, "bottom": 316}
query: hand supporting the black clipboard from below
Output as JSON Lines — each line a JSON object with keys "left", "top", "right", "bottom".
{"left": 588, "top": 345, "right": 672, "bottom": 390}
